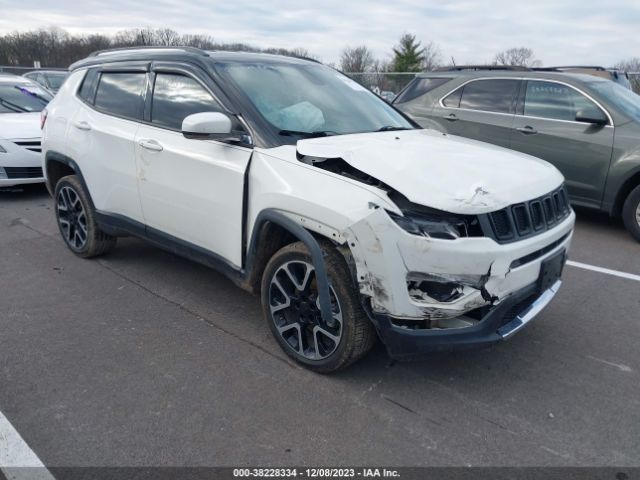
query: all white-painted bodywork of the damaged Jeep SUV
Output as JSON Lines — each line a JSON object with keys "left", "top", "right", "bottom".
{"left": 43, "top": 63, "right": 575, "bottom": 334}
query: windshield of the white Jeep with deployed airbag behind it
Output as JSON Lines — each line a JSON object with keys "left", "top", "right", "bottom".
{"left": 218, "top": 63, "right": 414, "bottom": 137}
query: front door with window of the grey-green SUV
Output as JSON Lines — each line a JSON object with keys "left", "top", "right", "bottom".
{"left": 511, "top": 80, "right": 614, "bottom": 207}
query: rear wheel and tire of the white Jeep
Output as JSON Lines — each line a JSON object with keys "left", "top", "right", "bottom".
{"left": 53, "top": 175, "right": 117, "bottom": 258}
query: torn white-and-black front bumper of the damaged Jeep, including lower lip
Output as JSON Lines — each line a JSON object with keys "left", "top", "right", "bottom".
{"left": 349, "top": 204, "right": 575, "bottom": 358}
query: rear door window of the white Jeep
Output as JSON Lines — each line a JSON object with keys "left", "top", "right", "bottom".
{"left": 94, "top": 72, "right": 147, "bottom": 120}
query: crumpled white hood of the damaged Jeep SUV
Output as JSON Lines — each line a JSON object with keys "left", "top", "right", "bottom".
{"left": 297, "top": 130, "right": 564, "bottom": 214}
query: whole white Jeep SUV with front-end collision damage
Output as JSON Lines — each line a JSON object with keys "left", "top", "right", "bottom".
{"left": 43, "top": 48, "right": 575, "bottom": 372}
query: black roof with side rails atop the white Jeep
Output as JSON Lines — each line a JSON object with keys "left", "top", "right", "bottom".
{"left": 69, "top": 47, "right": 319, "bottom": 71}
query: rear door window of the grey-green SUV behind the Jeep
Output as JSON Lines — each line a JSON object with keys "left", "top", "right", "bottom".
{"left": 460, "top": 79, "right": 520, "bottom": 113}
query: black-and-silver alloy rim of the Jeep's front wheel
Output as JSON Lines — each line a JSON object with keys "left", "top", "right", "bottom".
{"left": 269, "top": 260, "right": 343, "bottom": 360}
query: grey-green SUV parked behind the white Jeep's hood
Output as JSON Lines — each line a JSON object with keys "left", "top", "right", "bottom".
{"left": 393, "top": 67, "right": 640, "bottom": 241}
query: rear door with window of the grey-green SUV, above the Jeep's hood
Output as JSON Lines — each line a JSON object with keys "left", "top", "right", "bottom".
{"left": 432, "top": 78, "right": 521, "bottom": 147}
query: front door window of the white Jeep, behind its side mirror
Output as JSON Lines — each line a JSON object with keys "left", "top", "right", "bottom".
{"left": 151, "top": 73, "right": 222, "bottom": 130}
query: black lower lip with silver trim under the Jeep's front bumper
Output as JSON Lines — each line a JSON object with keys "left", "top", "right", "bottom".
{"left": 368, "top": 280, "right": 562, "bottom": 360}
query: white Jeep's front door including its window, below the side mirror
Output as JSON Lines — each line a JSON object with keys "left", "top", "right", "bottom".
{"left": 135, "top": 67, "right": 252, "bottom": 267}
